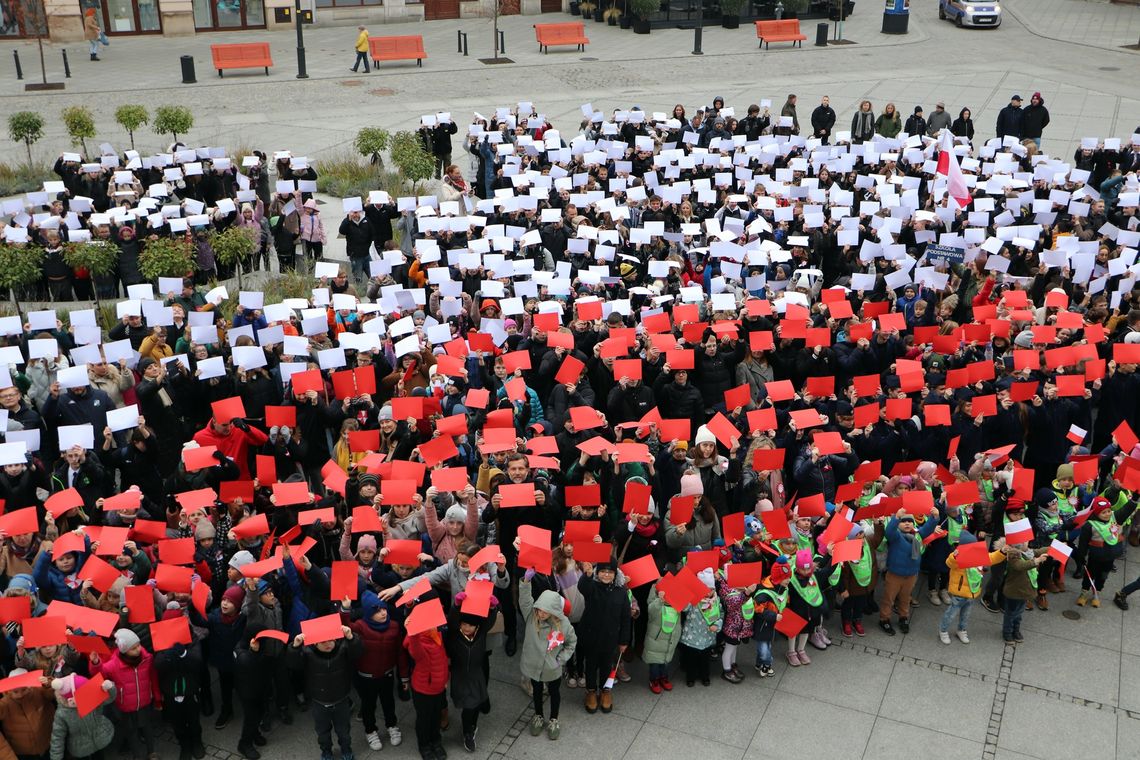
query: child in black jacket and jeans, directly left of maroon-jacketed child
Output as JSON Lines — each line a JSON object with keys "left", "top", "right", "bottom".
{"left": 286, "top": 615, "right": 364, "bottom": 760}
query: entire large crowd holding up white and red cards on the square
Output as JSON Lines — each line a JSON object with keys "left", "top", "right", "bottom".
{"left": 0, "top": 96, "right": 1140, "bottom": 760}
